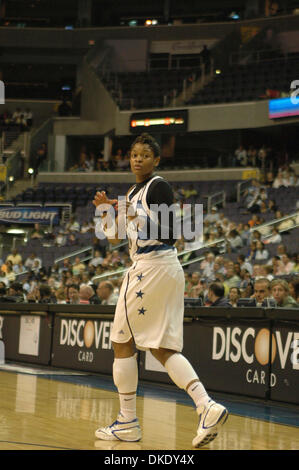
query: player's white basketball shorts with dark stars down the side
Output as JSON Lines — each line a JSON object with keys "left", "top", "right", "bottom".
{"left": 111, "top": 258, "right": 185, "bottom": 352}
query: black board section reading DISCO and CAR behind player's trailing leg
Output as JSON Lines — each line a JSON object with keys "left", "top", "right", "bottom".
{"left": 140, "top": 318, "right": 275, "bottom": 398}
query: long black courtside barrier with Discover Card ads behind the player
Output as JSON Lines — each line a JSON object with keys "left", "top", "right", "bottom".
{"left": 0, "top": 303, "right": 299, "bottom": 404}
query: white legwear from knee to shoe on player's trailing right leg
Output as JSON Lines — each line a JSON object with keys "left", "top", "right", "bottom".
{"left": 164, "top": 353, "right": 210, "bottom": 408}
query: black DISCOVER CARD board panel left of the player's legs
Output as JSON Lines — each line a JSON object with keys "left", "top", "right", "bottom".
{"left": 52, "top": 314, "right": 114, "bottom": 375}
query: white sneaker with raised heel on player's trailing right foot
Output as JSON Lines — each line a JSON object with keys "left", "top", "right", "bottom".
{"left": 192, "top": 400, "right": 228, "bottom": 447}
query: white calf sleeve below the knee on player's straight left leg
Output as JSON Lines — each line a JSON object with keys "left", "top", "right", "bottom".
{"left": 113, "top": 353, "right": 138, "bottom": 393}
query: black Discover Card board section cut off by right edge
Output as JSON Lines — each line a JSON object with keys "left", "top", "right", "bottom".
{"left": 270, "top": 321, "right": 299, "bottom": 404}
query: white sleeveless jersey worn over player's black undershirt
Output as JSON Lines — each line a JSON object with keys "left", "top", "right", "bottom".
{"left": 127, "top": 176, "right": 177, "bottom": 261}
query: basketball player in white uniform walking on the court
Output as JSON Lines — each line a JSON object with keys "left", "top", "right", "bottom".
{"left": 93, "top": 134, "right": 228, "bottom": 447}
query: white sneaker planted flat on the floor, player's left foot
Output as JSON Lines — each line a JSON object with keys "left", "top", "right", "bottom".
{"left": 95, "top": 414, "right": 141, "bottom": 442}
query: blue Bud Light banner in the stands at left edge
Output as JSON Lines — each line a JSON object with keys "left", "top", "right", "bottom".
{"left": 0, "top": 205, "right": 59, "bottom": 225}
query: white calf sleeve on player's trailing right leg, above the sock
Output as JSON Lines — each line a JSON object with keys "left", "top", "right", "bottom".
{"left": 164, "top": 353, "right": 198, "bottom": 390}
